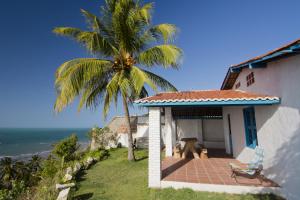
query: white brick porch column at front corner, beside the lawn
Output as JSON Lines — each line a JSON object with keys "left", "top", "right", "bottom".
{"left": 148, "top": 107, "right": 161, "bottom": 187}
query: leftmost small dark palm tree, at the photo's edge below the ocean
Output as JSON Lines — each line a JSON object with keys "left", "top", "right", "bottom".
{"left": 0, "top": 157, "right": 16, "bottom": 189}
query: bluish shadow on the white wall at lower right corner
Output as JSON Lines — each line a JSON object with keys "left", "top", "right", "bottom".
{"left": 265, "top": 124, "right": 300, "bottom": 200}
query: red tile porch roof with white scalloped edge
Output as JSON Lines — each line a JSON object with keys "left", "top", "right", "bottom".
{"left": 135, "top": 90, "right": 279, "bottom": 104}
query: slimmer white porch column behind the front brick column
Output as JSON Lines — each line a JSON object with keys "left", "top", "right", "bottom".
{"left": 165, "top": 107, "right": 174, "bottom": 157}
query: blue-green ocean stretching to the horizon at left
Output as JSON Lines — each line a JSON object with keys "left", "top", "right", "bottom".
{"left": 0, "top": 128, "right": 89, "bottom": 159}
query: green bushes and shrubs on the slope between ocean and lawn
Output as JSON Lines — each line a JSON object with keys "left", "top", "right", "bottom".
{"left": 0, "top": 128, "right": 111, "bottom": 200}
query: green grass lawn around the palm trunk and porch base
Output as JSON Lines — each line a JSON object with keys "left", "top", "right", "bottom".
{"left": 74, "top": 148, "right": 281, "bottom": 200}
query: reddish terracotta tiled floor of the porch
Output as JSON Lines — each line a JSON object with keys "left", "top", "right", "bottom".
{"left": 162, "top": 149, "right": 278, "bottom": 187}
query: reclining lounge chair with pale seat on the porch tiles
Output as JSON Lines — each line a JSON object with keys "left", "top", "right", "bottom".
{"left": 229, "top": 146, "right": 264, "bottom": 184}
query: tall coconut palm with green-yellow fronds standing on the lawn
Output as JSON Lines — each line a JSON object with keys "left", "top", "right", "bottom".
{"left": 54, "top": 0, "right": 182, "bottom": 160}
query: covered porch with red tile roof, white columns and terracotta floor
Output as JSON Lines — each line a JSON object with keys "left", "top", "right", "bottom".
{"left": 136, "top": 91, "right": 280, "bottom": 194}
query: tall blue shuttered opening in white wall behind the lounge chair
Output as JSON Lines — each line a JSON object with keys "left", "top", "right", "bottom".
{"left": 243, "top": 107, "right": 258, "bottom": 148}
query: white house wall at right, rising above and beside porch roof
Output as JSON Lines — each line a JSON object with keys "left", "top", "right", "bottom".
{"left": 232, "top": 55, "right": 300, "bottom": 199}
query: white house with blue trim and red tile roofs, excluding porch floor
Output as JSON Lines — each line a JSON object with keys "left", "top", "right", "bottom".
{"left": 135, "top": 40, "right": 300, "bottom": 199}
